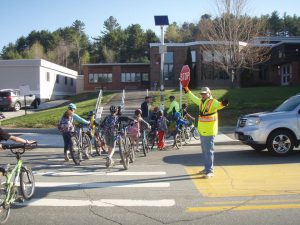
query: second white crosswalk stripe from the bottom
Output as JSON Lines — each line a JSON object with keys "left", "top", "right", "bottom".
{"left": 35, "top": 182, "right": 170, "bottom": 188}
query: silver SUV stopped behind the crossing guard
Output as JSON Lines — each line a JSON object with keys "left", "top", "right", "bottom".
{"left": 235, "top": 94, "right": 300, "bottom": 155}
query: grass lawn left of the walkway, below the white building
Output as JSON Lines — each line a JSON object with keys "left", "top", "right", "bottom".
{"left": 1, "top": 92, "right": 114, "bottom": 128}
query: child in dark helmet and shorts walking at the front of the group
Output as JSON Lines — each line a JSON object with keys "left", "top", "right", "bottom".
{"left": 100, "top": 105, "right": 118, "bottom": 168}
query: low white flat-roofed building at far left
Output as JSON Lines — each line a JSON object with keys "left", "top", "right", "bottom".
{"left": 0, "top": 59, "right": 78, "bottom": 101}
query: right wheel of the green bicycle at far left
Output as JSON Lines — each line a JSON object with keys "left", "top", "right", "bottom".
{"left": 20, "top": 167, "right": 35, "bottom": 200}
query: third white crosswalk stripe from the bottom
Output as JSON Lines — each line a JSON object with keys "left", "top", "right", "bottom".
{"left": 33, "top": 171, "right": 166, "bottom": 176}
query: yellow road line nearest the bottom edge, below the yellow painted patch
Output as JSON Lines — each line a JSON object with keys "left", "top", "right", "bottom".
{"left": 186, "top": 204, "right": 300, "bottom": 212}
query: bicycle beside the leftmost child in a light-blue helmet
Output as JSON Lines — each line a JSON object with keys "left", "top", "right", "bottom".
{"left": 70, "top": 125, "right": 92, "bottom": 165}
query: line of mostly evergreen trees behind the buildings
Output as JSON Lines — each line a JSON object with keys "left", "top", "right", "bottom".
{"left": 1, "top": 11, "right": 300, "bottom": 72}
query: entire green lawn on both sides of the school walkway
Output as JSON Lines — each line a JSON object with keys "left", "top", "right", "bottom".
{"left": 2, "top": 87, "right": 300, "bottom": 128}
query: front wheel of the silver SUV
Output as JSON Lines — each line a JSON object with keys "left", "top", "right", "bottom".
{"left": 267, "top": 130, "right": 295, "bottom": 156}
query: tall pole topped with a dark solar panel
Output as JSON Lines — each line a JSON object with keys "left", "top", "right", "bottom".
{"left": 154, "top": 16, "right": 169, "bottom": 110}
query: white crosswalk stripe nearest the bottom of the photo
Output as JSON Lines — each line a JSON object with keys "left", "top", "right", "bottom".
{"left": 22, "top": 198, "right": 175, "bottom": 207}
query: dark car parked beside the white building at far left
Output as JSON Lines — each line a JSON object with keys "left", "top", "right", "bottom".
{"left": 0, "top": 89, "right": 41, "bottom": 111}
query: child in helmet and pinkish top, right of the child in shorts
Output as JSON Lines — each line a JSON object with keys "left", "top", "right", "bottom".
{"left": 128, "top": 109, "right": 151, "bottom": 152}
